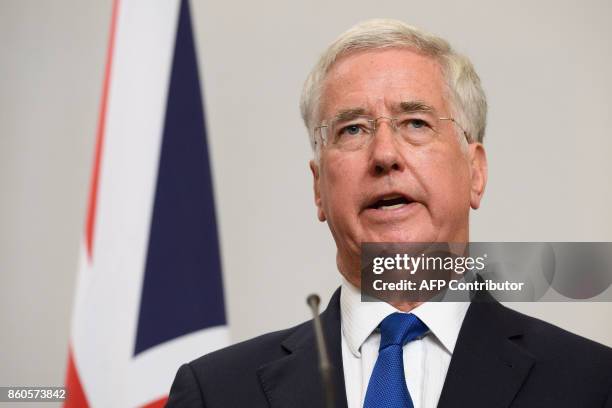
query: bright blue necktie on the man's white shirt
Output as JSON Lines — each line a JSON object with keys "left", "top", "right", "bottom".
{"left": 363, "top": 313, "right": 428, "bottom": 408}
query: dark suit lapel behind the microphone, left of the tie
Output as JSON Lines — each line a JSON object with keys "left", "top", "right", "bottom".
{"left": 257, "top": 289, "right": 347, "bottom": 408}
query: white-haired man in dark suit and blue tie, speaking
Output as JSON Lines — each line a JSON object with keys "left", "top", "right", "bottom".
{"left": 168, "top": 20, "right": 612, "bottom": 408}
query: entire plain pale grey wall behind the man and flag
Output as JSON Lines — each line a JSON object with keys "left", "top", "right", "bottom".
{"left": 0, "top": 0, "right": 612, "bottom": 396}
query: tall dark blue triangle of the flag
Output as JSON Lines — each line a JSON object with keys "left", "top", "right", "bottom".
{"left": 134, "top": 0, "right": 226, "bottom": 355}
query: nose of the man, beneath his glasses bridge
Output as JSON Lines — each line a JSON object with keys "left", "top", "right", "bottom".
{"left": 369, "top": 120, "right": 404, "bottom": 176}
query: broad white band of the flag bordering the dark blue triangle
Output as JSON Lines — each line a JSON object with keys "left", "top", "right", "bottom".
{"left": 67, "top": 0, "right": 228, "bottom": 407}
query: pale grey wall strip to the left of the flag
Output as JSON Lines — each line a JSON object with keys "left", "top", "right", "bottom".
{"left": 0, "top": 0, "right": 110, "bottom": 390}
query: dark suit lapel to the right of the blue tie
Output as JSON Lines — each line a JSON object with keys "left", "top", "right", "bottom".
{"left": 438, "top": 294, "right": 535, "bottom": 408}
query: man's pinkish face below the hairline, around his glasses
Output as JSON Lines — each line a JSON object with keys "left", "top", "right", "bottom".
{"left": 310, "top": 48, "right": 486, "bottom": 284}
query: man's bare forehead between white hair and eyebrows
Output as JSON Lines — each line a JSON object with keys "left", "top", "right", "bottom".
{"left": 319, "top": 48, "right": 448, "bottom": 118}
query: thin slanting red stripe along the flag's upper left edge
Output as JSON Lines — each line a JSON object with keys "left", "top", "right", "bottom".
{"left": 85, "top": 0, "right": 119, "bottom": 261}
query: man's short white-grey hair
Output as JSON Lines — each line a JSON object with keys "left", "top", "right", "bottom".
{"left": 300, "top": 19, "right": 487, "bottom": 152}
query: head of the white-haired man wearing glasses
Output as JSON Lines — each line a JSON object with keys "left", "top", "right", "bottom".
{"left": 301, "top": 20, "right": 487, "bottom": 284}
